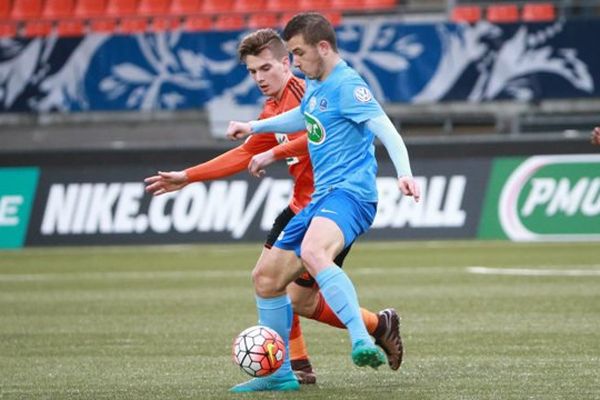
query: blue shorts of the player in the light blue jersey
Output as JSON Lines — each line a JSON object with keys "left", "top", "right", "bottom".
{"left": 274, "top": 189, "right": 377, "bottom": 257}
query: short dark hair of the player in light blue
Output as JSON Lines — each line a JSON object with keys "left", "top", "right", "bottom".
{"left": 282, "top": 12, "right": 337, "bottom": 52}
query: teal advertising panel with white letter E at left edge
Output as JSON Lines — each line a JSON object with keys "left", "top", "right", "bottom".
{"left": 0, "top": 168, "right": 39, "bottom": 249}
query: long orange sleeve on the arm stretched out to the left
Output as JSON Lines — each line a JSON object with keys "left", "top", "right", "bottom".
{"left": 185, "top": 135, "right": 277, "bottom": 182}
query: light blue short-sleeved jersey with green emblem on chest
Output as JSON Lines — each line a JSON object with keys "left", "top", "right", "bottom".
{"left": 300, "top": 61, "right": 385, "bottom": 202}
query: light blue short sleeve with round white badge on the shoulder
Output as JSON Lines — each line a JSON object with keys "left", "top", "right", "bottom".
{"left": 339, "top": 79, "right": 385, "bottom": 124}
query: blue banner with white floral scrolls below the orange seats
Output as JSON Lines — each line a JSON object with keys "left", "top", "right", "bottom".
{"left": 0, "top": 18, "right": 600, "bottom": 112}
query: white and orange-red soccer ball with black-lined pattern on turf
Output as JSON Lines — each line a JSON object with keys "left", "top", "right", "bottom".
{"left": 233, "top": 325, "right": 285, "bottom": 377}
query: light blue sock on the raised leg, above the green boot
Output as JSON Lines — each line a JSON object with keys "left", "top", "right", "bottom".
{"left": 315, "top": 265, "right": 371, "bottom": 345}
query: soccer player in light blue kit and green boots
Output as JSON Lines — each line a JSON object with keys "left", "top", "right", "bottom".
{"left": 227, "top": 13, "right": 420, "bottom": 392}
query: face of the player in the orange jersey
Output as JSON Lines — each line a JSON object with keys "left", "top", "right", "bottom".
{"left": 245, "top": 49, "right": 290, "bottom": 98}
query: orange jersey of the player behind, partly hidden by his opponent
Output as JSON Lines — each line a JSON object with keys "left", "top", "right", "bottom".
{"left": 186, "top": 76, "right": 314, "bottom": 213}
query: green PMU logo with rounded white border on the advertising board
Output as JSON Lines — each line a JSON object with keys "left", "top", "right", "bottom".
{"left": 499, "top": 154, "right": 600, "bottom": 241}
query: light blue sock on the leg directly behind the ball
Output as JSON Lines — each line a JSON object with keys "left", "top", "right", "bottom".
{"left": 256, "top": 294, "right": 293, "bottom": 378}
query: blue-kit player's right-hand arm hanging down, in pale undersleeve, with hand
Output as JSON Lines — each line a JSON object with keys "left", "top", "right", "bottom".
{"left": 367, "top": 114, "right": 421, "bottom": 203}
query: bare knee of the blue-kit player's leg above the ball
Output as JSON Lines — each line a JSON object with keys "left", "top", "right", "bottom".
{"left": 252, "top": 247, "right": 303, "bottom": 296}
